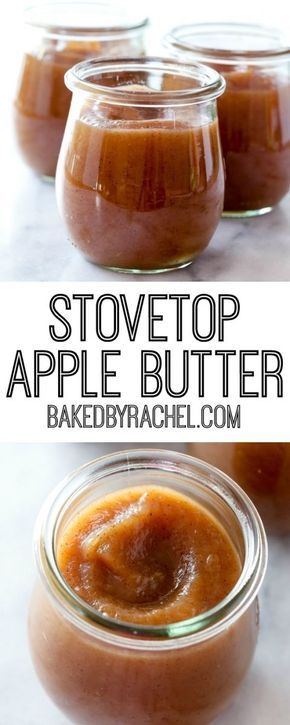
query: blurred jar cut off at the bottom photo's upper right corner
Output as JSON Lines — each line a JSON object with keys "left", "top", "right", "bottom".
{"left": 188, "top": 443, "right": 290, "bottom": 534}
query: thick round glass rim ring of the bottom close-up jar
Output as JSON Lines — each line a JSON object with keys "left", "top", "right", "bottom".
{"left": 35, "top": 449, "right": 267, "bottom": 649}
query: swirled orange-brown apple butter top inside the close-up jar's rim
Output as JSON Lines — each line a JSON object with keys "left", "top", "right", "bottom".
{"left": 57, "top": 486, "right": 241, "bottom": 625}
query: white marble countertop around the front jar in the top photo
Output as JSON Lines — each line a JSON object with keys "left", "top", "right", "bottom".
{"left": 0, "top": 115, "right": 290, "bottom": 282}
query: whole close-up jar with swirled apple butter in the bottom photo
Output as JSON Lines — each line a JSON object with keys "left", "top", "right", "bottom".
{"left": 29, "top": 450, "right": 267, "bottom": 725}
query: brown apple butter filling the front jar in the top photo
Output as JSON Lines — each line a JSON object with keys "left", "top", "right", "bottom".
{"left": 58, "top": 117, "right": 224, "bottom": 270}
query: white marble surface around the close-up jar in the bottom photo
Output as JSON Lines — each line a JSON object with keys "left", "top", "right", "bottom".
{"left": 0, "top": 444, "right": 290, "bottom": 725}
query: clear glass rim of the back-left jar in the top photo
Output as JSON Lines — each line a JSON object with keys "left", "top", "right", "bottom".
{"left": 24, "top": 0, "right": 149, "bottom": 36}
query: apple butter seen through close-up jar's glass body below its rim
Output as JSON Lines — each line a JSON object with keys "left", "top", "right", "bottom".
{"left": 29, "top": 586, "right": 259, "bottom": 725}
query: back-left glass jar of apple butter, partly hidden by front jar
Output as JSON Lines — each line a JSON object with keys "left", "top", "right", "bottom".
{"left": 14, "top": 1, "right": 148, "bottom": 178}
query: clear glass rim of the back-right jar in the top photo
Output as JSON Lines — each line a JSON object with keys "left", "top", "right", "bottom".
{"left": 164, "top": 22, "right": 290, "bottom": 65}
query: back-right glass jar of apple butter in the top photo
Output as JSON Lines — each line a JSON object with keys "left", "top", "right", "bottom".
{"left": 165, "top": 23, "right": 290, "bottom": 217}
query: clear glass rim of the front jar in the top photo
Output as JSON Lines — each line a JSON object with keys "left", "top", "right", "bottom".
{"left": 65, "top": 56, "right": 225, "bottom": 107}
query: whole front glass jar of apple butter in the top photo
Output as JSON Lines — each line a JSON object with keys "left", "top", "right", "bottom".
{"left": 57, "top": 58, "right": 224, "bottom": 273}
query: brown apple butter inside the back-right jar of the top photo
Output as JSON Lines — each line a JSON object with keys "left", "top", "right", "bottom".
{"left": 217, "top": 66, "right": 290, "bottom": 212}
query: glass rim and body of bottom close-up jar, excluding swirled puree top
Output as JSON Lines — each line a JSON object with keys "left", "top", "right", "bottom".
{"left": 29, "top": 450, "right": 267, "bottom": 725}
